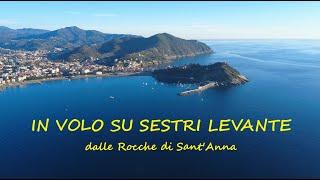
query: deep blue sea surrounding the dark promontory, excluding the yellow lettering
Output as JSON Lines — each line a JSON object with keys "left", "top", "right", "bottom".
{"left": 0, "top": 40, "right": 320, "bottom": 178}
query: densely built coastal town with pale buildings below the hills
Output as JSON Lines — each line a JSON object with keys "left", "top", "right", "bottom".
{"left": 0, "top": 48, "right": 143, "bottom": 90}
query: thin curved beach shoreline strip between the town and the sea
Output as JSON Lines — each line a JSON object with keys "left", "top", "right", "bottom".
{"left": 0, "top": 72, "right": 139, "bottom": 92}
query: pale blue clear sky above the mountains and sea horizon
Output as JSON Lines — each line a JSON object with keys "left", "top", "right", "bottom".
{"left": 0, "top": 1, "right": 320, "bottom": 39}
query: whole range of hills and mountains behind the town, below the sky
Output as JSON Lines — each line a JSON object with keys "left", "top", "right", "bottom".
{"left": 0, "top": 26, "right": 213, "bottom": 65}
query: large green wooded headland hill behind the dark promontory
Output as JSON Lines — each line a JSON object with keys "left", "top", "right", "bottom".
{"left": 59, "top": 33, "right": 212, "bottom": 64}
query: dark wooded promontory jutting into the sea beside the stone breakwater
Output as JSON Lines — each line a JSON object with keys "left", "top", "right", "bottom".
{"left": 152, "top": 62, "right": 248, "bottom": 86}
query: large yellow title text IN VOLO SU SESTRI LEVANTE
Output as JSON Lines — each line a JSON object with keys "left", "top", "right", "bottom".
{"left": 31, "top": 118, "right": 292, "bottom": 133}
